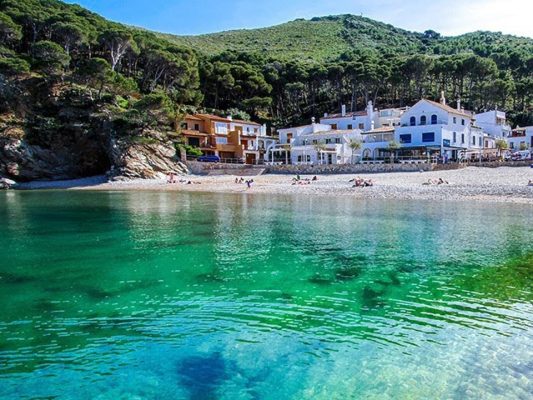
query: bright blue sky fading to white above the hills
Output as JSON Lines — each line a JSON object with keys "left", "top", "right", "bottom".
{"left": 66, "top": 0, "right": 533, "bottom": 38}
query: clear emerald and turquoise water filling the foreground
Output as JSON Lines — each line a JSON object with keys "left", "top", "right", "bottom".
{"left": 0, "top": 192, "right": 533, "bottom": 399}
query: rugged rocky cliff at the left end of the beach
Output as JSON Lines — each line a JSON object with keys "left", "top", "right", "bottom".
{"left": 0, "top": 76, "right": 187, "bottom": 181}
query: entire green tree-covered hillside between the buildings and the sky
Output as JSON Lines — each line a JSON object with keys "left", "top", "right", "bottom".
{"left": 0, "top": 0, "right": 533, "bottom": 131}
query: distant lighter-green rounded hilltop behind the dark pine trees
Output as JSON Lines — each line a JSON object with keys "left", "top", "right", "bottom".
{"left": 160, "top": 15, "right": 533, "bottom": 62}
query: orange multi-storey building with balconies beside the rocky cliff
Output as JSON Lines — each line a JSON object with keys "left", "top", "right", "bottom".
{"left": 181, "top": 114, "right": 266, "bottom": 164}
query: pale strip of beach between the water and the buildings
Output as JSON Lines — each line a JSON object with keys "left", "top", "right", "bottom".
{"left": 11, "top": 167, "right": 533, "bottom": 204}
